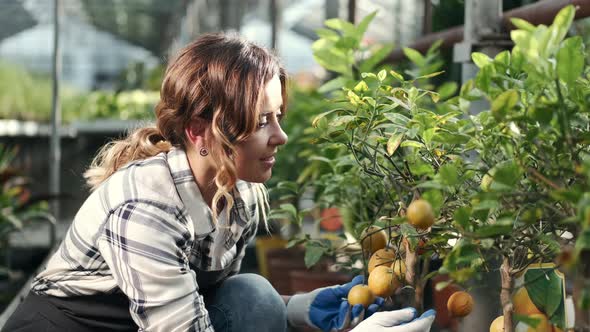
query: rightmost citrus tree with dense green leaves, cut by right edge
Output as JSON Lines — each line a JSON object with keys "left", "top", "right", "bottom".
{"left": 450, "top": 6, "right": 590, "bottom": 331}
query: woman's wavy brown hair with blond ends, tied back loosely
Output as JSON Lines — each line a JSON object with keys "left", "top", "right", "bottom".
{"left": 84, "top": 33, "right": 287, "bottom": 222}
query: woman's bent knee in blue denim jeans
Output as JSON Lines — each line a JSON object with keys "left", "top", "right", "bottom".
{"left": 203, "top": 273, "right": 287, "bottom": 332}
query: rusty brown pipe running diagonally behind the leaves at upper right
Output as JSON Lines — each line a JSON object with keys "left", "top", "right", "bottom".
{"left": 385, "top": 0, "right": 590, "bottom": 63}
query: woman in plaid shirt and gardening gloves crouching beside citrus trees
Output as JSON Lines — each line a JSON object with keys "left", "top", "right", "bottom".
{"left": 3, "top": 34, "right": 432, "bottom": 331}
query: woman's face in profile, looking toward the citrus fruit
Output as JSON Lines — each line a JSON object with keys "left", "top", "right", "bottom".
{"left": 234, "top": 75, "right": 287, "bottom": 183}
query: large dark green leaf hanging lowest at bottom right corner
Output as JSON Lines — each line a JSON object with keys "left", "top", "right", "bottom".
{"left": 524, "top": 268, "right": 565, "bottom": 327}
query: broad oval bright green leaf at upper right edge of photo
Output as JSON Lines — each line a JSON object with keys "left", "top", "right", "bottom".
{"left": 557, "top": 36, "right": 585, "bottom": 84}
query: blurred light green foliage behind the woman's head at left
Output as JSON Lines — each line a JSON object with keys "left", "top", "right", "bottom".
{"left": 0, "top": 62, "right": 163, "bottom": 123}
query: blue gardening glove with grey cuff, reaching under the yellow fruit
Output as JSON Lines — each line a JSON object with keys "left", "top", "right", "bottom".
{"left": 287, "top": 275, "right": 384, "bottom": 331}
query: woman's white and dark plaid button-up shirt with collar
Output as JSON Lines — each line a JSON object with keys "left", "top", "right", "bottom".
{"left": 32, "top": 149, "right": 268, "bottom": 332}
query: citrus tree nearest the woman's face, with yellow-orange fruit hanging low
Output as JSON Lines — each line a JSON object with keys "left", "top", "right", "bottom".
{"left": 274, "top": 10, "right": 474, "bottom": 312}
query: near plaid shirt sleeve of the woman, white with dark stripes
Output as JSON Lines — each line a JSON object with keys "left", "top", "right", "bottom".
{"left": 98, "top": 203, "right": 214, "bottom": 331}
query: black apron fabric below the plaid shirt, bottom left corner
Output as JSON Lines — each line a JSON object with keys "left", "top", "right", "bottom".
{"left": 2, "top": 292, "right": 138, "bottom": 332}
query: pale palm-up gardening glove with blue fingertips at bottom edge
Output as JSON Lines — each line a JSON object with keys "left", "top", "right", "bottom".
{"left": 351, "top": 308, "right": 436, "bottom": 332}
